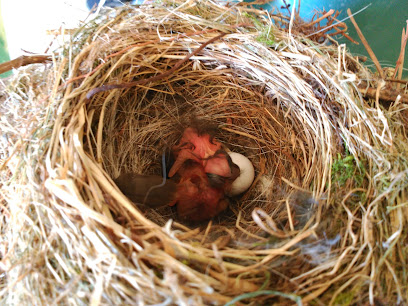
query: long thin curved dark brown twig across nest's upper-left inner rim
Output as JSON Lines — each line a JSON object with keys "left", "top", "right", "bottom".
{"left": 86, "top": 33, "right": 227, "bottom": 99}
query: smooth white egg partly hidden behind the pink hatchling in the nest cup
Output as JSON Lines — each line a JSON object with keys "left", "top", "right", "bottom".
{"left": 228, "top": 152, "right": 255, "bottom": 196}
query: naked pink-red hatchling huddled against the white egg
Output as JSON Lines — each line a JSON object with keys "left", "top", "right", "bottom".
{"left": 169, "top": 127, "right": 239, "bottom": 221}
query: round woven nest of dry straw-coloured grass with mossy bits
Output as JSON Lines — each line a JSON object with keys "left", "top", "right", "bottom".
{"left": 0, "top": 1, "right": 408, "bottom": 305}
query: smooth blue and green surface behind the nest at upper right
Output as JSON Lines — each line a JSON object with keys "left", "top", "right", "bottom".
{"left": 264, "top": 0, "right": 408, "bottom": 75}
